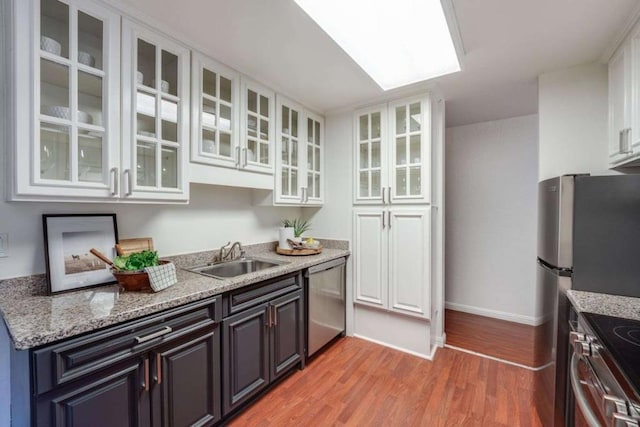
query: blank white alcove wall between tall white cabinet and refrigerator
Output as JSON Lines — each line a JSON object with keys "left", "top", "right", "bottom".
{"left": 445, "top": 115, "right": 538, "bottom": 324}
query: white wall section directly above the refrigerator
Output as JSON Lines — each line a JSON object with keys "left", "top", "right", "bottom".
{"left": 538, "top": 63, "right": 610, "bottom": 180}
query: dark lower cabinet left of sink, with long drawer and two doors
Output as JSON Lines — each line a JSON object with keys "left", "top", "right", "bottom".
{"left": 30, "top": 297, "right": 222, "bottom": 427}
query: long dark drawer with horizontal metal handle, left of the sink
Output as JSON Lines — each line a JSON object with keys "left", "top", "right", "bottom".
{"left": 32, "top": 297, "right": 222, "bottom": 394}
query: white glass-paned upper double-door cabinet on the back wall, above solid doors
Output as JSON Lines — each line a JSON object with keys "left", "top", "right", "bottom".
{"left": 354, "top": 96, "right": 431, "bottom": 204}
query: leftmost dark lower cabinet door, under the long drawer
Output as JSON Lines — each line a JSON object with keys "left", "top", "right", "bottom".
{"left": 36, "top": 358, "right": 149, "bottom": 427}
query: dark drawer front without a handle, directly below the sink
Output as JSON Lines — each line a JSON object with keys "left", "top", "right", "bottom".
{"left": 223, "top": 272, "right": 301, "bottom": 317}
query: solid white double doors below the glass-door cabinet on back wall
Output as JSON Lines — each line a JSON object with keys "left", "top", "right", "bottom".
{"left": 353, "top": 207, "right": 431, "bottom": 319}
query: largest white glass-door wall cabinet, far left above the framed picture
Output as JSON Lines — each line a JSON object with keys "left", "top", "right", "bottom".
{"left": 8, "top": 0, "right": 189, "bottom": 201}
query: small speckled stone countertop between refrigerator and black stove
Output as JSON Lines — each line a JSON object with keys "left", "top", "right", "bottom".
{"left": 567, "top": 289, "right": 640, "bottom": 320}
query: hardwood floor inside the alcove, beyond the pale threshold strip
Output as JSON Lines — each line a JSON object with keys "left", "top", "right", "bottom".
{"left": 444, "top": 310, "right": 544, "bottom": 367}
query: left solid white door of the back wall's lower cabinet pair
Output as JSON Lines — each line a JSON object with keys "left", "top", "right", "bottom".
{"left": 353, "top": 209, "right": 388, "bottom": 308}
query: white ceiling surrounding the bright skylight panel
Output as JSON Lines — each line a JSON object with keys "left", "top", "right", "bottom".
{"left": 112, "top": 0, "right": 640, "bottom": 126}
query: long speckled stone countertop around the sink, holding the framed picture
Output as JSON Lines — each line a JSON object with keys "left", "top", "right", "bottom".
{"left": 0, "top": 240, "right": 350, "bottom": 350}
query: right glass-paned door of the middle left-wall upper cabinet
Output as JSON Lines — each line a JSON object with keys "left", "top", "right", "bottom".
{"left": 236, "top": 79, "right": 276, "bottom": 175}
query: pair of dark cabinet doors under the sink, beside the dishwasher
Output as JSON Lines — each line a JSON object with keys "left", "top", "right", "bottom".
{"left": 222, "top": 290, "right": 304, "bottom": 415}
